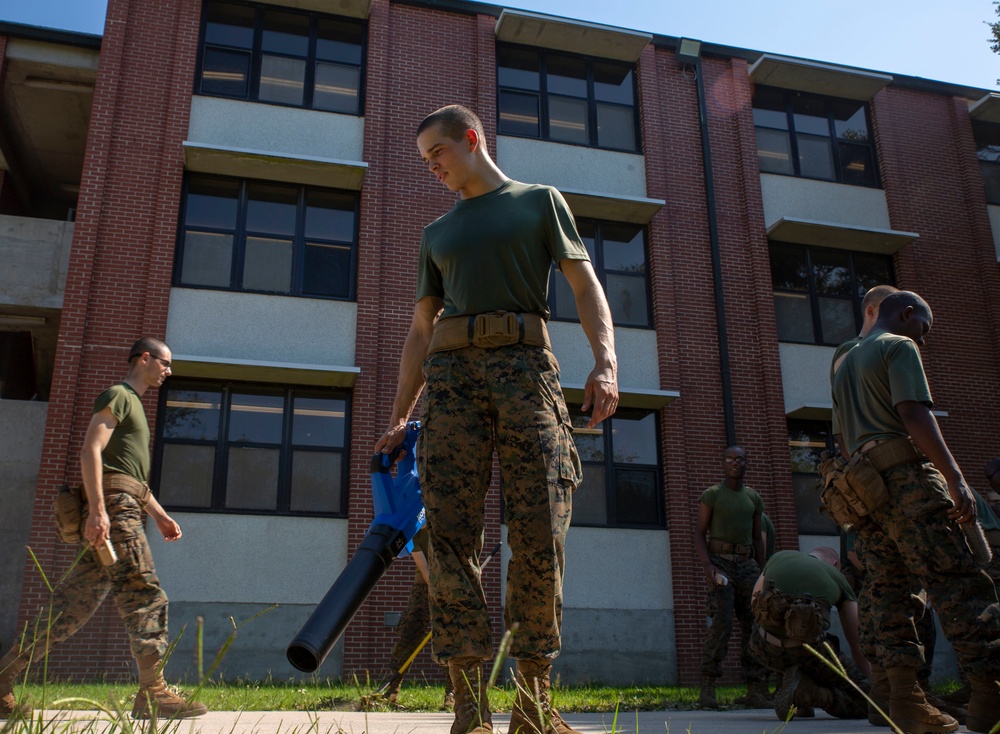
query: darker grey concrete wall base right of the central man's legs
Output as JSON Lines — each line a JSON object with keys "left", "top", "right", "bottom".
{"left": 552, "top": 608, "right": 677, "bottom": 686}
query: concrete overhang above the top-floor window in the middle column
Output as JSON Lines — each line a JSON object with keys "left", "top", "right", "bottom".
{"left": 496, "top": 8, "right": 653, "bottom": 63}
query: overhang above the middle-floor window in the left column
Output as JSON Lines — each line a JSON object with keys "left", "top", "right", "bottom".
{"left": 184, "top": 141, "right": 368, "bottom": 191}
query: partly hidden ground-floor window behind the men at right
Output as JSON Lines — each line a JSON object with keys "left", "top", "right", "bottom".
{"left": 788, "top": 420, "right": 840, "bottom": 535}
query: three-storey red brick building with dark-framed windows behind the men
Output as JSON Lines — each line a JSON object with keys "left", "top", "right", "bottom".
{"left": 0, "top": 0, "right": 1000, "bottom": 684}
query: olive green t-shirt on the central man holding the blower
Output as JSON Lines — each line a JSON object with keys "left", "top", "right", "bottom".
{"left": 416, "top": 179, "right": 590, "bottom": 319}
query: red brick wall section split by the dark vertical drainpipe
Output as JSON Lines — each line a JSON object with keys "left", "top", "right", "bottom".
{"left": 640, "top": 49, "right": 798, "bottom": 684}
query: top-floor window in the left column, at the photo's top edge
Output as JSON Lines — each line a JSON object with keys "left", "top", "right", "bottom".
{"left": 195, "top": 3, "right": 365, "bottom": 115}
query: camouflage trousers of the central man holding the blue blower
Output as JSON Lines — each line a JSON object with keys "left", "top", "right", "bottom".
{"left": 417, "top": 344, "right": 582, "bottom": 663}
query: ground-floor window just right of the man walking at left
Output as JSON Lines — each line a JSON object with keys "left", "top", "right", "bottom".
{"left": 155, "top": 378, "right": 350, "bottom": 516}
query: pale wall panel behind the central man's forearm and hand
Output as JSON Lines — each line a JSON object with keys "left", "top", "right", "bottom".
{"left": 548, "top": 321, "right": 660, "bottom": 390}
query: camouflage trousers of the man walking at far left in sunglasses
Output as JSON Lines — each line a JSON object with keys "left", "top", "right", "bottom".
{"left": 21, "top": 492, "right": 169, "bottom": 660}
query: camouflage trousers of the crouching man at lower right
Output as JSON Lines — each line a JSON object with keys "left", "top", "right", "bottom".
{"left": 750, "top": 625, "right": 871, "bottom": 719}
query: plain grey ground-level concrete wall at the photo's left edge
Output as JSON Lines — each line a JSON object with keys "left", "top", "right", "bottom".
{"left": 0, "top": 400, "right": 49, "bottom": 645}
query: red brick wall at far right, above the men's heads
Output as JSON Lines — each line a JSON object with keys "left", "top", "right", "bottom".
{"left": 873, "top": 88, "right": 1000, "bottom": 480}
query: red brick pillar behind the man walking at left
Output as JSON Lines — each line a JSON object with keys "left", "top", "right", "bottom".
{"left": 20, "top": 0, "right": 200, "bottom": 677}
